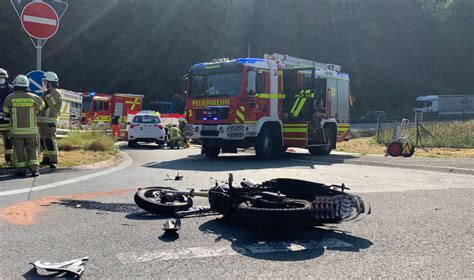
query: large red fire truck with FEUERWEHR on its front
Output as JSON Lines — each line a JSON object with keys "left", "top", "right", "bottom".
{"left": 185, "top": 53, "right": 351, "bottom": 159}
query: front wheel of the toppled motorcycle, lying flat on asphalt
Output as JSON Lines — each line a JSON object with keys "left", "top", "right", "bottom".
{"left": 133, "top": 187, "right": 193, "bottom": 216}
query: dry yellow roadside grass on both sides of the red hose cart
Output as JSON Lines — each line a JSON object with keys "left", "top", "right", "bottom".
{"left": 337, "top": 137, "right": 474, "bottom": 158}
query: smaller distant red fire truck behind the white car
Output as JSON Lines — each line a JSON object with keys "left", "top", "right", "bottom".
{"left": 82, "top": 93, "right": 143, "bottom": 128}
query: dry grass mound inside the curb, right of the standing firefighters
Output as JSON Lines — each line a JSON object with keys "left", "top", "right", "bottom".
{"left": 58, "top": 130, "right": 114, "bottom": 151}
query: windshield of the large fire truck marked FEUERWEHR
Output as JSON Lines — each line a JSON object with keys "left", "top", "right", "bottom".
{"left": 190, "top": 73, "right": 242, "bottom": 98}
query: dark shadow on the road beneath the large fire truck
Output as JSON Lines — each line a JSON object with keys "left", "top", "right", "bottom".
{"left": 143, "top": 153, "right": 354, "bottom": 171}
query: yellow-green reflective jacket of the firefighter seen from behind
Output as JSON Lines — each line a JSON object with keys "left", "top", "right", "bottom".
{"left": 3, "top": 91, "right": 44, "bottom": 138}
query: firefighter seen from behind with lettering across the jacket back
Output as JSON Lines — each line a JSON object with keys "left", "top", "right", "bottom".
{"left": 3, "top": 75, "right": 44, "bottom": 177}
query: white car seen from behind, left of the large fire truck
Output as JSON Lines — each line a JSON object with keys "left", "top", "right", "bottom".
{"left": 127, "top": 111, "right": 166, "bottom": 147}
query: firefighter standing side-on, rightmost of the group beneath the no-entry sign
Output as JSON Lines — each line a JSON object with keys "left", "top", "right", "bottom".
{"left": 38, "top": 72, "right": 62, "bottom": 168}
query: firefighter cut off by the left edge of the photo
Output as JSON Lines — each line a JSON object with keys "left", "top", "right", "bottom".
{"left": 0, "top": 68, "right": 13, "bottom": 166}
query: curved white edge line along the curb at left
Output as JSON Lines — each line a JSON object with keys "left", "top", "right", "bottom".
{"left": 0, "top": 153, "right": 133, "bottom": 197}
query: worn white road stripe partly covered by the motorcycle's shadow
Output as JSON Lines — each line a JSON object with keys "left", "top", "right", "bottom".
{"left": 117, "top": 238, "right": 354, "bottom": 264}
